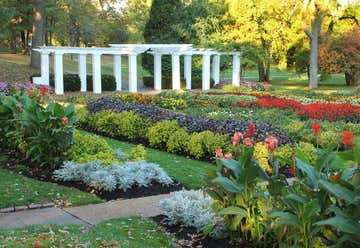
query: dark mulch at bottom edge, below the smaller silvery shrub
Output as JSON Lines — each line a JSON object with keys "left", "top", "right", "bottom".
{"left": 152, "top": 215, "right": 252, "bottom": 248}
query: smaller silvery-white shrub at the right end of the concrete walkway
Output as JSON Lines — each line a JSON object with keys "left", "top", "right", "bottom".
{"left": 159, "top": 190, "right": 221, "bottom": 236}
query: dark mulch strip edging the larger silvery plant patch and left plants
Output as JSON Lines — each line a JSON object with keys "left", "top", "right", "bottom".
{"left": 0, "top": 149, "right": 183, "bottom": 201}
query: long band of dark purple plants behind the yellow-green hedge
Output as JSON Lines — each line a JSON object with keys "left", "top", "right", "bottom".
{"left": 87, "top": 97, "right": 291, "bottom": 144}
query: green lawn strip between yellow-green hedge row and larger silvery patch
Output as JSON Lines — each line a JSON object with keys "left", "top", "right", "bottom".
{"left": 104, "top": 134, "right": 214, "bottom": 189}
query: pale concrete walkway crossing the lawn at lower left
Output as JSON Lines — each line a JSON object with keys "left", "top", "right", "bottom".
{"left": 0, "top": 194, "right": 169, "bottom": 228}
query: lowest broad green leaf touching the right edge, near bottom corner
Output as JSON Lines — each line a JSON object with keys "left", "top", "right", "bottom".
{"left": 314, "top": 216, "right": 360, "bottom": 234}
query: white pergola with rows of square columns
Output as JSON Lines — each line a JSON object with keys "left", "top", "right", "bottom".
{"left": 33, "top": 44, "right": 241, "bottom": 95}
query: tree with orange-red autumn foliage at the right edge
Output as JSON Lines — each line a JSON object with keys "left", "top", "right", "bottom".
{"left": 319, "top": 26, "right": 360, "bottom": 86}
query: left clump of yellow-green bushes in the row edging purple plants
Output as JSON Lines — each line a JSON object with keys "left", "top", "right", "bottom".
{"left": 94, "top": 110, "right": 149, "bottom": 141}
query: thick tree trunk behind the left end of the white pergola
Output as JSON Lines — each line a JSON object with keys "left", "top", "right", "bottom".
{"left": 31, "top": 0, "right": 45, "bottom": 68}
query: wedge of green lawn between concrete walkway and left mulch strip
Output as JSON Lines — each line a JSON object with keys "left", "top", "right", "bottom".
{"left": 0, "top": 169, "right": 101, "bottom": 208}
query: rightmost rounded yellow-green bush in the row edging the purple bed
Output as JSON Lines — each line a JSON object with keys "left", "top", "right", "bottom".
{"left": 187, "top": 131, "right": 228, "bottom": 159}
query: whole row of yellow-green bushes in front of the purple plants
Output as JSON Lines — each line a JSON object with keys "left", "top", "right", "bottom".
{"left": 78, "top": 109, "right": 230, "bottom": 160}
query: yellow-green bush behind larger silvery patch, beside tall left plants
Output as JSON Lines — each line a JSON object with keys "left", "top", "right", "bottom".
{"left": 68, "top": 131, "right": 117, "bottom": 165}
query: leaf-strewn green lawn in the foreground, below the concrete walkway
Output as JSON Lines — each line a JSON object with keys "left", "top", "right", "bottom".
{"left": 0, "top": 217, "right": 175, "bottom": 248}
